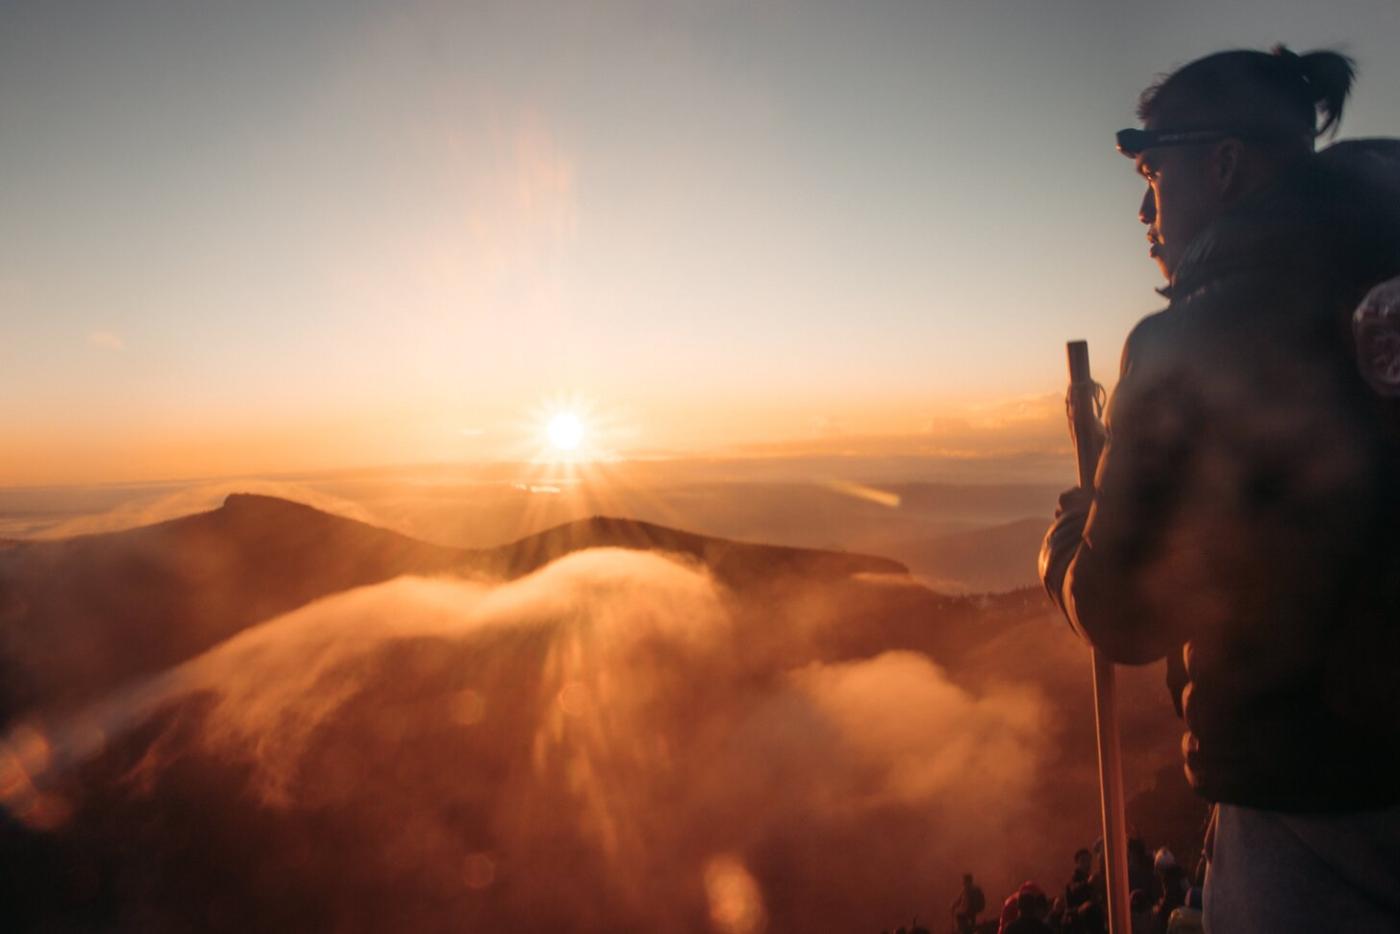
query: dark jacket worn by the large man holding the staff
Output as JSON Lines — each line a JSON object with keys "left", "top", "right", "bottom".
{"left": 1046, "top": 140, "right": 1400, "bottom": 811}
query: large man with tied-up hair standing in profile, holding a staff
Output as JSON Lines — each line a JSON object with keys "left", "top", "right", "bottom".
{"left": 1042, "top": 49, "right": 1400, "bottom": 934}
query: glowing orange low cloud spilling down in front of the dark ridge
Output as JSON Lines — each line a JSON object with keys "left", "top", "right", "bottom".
{"left": 0, "top": 550, "right": 1054, "bottom": 934}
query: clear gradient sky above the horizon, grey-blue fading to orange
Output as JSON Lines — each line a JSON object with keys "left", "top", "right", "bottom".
{"left": 8, "top": 0, "right": 1400, "bottom": 486}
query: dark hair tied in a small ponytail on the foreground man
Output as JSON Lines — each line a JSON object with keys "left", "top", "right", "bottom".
{"left": 1138, "top": 45, "right": 1357, "bottom": 147}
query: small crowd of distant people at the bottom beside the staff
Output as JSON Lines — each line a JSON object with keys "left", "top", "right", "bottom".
{"left": 881, "top": 837, "right": 1203, "bottom": 934}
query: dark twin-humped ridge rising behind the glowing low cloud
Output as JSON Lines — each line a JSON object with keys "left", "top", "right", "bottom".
{"left": 0, "top": 493, "right": 907, "bottom": 723}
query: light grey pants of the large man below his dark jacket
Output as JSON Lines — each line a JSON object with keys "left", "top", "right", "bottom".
{"left": 1205, "top": 804, "right": 1400, "bottom": 934}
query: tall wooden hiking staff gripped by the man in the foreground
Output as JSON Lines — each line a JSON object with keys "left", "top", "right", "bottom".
{"left": 1065, "top": 340, "right": 1133, "bottom": 934}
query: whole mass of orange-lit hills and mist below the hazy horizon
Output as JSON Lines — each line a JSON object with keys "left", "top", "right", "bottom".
{"left": 0, "top": 496, "right": 1200, "bottom": 931}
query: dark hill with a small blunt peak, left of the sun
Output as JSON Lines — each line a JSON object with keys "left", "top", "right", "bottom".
{"left": 0, "top": 496, "right": 469, "bottom": 716}
